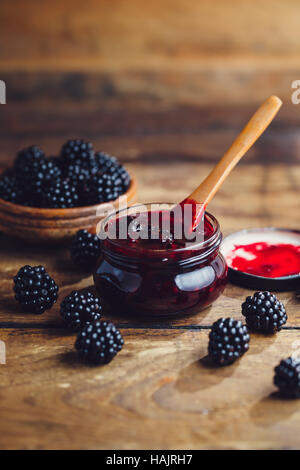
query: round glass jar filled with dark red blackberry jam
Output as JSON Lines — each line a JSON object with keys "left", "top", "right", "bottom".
{"left": 94, "top": 204, "right": 227, "bottom": 318}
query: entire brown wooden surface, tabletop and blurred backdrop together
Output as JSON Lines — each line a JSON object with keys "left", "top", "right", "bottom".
{"left": 0, "top": 0, "right": 300, "bottom": 449}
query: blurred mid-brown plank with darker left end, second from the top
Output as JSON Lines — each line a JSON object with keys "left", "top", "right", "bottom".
{"left": 0, "top": 67, "right": 299, "bottom": 108}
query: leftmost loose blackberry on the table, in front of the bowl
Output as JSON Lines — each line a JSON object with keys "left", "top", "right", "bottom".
{"left": 14, "top": 265, "right": 58, "bottom": 313}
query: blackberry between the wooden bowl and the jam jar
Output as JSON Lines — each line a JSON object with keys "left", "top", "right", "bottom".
{"left": 71, "top": 230, "right": 101, "bottom": 271}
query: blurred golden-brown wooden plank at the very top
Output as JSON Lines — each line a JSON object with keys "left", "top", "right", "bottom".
{"left": 0, "top": 0, "right": 299, "bottom": 65}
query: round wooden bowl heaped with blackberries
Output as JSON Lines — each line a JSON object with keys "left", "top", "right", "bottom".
{"left": 0, "top": 139, "right": 136, "bottom": 244}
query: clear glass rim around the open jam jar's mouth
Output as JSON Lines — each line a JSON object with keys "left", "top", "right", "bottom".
{"left": 99, "top": 202, "right": 222, "bottom": 254}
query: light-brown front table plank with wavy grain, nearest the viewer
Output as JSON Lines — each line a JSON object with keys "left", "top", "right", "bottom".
{"left": 0, "top": 329, "right": 300, "bottom": 449}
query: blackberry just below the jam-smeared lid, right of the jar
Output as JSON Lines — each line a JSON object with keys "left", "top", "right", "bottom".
{"left": 242, "top": 292, "right": 287, "bottom": 333}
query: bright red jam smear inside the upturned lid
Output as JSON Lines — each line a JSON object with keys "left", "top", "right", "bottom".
{"left": 229, "top": 242, "right": 300, "bottom": 278}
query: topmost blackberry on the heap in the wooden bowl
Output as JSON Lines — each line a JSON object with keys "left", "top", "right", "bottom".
{"left": 61, "top": 139, "right": 96, "bottom": 169}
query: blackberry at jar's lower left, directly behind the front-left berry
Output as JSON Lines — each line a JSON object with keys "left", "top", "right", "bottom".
{"left": 60, "top": 290, "right": 102, "bottom": 331}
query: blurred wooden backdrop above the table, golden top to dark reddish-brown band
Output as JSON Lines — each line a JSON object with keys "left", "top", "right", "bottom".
{"left": 0, "top": 0, "right": 300, "bottom": 164}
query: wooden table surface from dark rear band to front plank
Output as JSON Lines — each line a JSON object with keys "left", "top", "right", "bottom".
{"left": 0, "top": 103, "right": 300, "bottom": 449}
